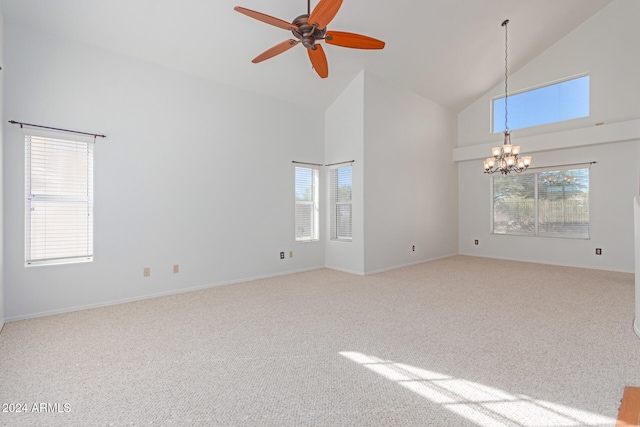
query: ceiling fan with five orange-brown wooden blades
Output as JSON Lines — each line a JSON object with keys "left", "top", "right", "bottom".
{"left": 233, "top": 0, "right": 384, "bottom": 79}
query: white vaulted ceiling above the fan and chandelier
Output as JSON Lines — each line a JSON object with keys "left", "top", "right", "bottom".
{"left": 2, "top": 0, "right": 611, "bottom": 112}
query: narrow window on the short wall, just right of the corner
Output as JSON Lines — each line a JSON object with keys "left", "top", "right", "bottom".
{"left": 330, "top": 166, "right": 353, "bottom": 241}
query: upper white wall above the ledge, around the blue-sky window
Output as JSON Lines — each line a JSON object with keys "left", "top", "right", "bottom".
{"left": 458, "top": 0, "right": 640, "bottom": 149}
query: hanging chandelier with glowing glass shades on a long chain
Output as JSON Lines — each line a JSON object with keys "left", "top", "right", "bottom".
{"left": 484, "top": 19, "right": 531, "bottom": 175}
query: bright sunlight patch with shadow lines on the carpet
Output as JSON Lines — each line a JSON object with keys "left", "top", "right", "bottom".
{"left": 340, "top": 351, "right": 616, "bottom": 427}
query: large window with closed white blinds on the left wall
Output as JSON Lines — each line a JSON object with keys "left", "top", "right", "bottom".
{"left": 25, "top": 134, "right": 93, "bottom": 265}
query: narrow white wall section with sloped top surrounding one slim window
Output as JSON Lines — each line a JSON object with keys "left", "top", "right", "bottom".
{"left": 324, "top": 71, "right": 366, "bottom": 274}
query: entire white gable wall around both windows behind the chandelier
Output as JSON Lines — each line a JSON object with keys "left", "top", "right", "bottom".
{"left": 454, "top": 0, "right": 640, "bottom": 272}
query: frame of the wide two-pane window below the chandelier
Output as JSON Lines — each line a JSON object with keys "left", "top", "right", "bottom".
{"left": 489, "top": 163, "right": 592, "bottom": 240}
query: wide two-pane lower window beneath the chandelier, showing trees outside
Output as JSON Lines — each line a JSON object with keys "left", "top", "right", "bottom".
{"left": 492, "top": 168, "right": 589, "bottom": 239}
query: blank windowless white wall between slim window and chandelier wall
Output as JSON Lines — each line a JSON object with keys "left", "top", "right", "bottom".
{"left": 364, "top": 72, "right": 458, "bottom": 273}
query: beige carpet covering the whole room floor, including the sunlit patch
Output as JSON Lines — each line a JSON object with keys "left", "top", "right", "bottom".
{"left": 0, "top": 256, "right": 640, "bottom": 427}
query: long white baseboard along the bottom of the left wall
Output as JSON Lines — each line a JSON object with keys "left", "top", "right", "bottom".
{"left": 5, "top": 266, "right": 325, "bottom": 323}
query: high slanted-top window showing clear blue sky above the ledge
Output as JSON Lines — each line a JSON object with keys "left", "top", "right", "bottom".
{"left": 492, "top": 76, "right": 589, "bottom": 133}
